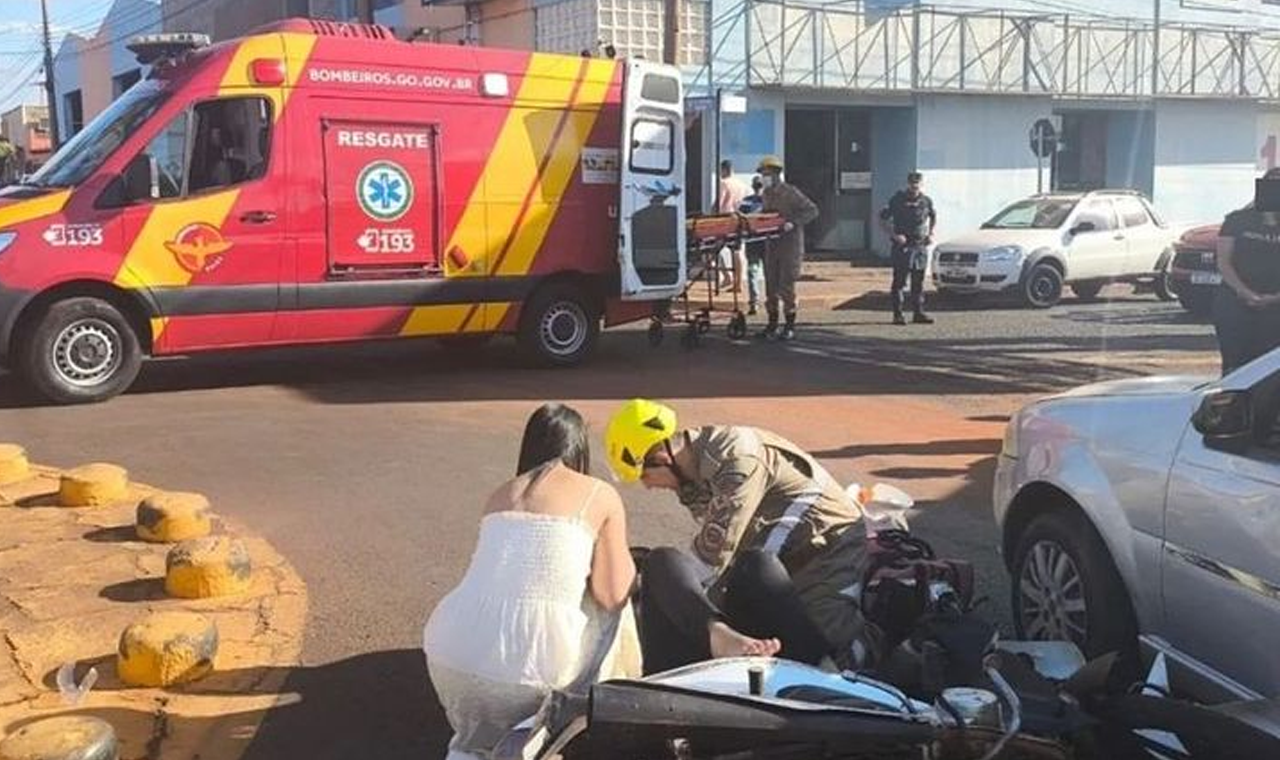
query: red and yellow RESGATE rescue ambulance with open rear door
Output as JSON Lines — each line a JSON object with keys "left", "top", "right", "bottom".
{"left": 0, "top": 20, "right": 686, "bottom": 403}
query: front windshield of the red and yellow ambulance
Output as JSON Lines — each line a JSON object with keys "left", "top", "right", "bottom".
{"left": 24, "top": 79, "right": 166, "bottom": 187}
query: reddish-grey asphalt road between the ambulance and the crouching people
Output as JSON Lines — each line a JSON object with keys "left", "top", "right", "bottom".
{"left": 0, "top": 282, "right": 1217, "bottom": 757}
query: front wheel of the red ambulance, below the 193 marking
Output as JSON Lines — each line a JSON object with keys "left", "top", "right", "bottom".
{"left": 19, "top": 297, "right": 142, "bottom": 404}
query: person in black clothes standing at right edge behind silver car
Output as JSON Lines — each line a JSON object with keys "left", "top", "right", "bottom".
{"left": 1213, "top": 169, "right": 1280, "bottom": 375}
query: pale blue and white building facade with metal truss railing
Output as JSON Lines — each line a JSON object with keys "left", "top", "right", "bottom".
{"left": 687, "top": 0, "right": 1280, "bottom": 252}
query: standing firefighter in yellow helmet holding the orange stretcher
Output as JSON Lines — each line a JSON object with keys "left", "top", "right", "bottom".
{"left": 756, "top": 156, "right": 818, "bottom": 340}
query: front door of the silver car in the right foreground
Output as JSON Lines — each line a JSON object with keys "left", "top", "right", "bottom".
{"left": 1161, "top": 360, "right": 1280, "bottom": 695}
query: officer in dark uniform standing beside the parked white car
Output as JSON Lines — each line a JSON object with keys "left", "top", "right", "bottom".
{"left": 881, "top": 171, "right": 938, "bottom": 325}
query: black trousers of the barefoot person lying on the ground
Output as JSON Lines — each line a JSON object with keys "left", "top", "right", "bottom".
{"left": 639, "top": 548, "right": 831, "bottom": 674}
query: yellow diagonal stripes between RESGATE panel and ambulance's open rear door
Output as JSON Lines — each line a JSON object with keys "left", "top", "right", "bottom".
{"left": 401, "top": 52, "right": 616, "bottom": 335}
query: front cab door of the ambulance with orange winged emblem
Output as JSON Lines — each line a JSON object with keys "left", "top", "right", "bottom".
{"left": 113, "top": 93, "right": 285, "bottom": 353}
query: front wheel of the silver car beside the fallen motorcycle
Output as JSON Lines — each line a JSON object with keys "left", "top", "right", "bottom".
{"left": 1012, "top": 511, "right": 1138, "bottom": 660}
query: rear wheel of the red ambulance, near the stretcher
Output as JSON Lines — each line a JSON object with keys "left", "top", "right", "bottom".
{"left": 517, "top": 281, "right": 600, "bottom": 367}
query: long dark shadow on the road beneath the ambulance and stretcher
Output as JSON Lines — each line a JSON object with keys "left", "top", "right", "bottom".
{"left": 0, "top": 325, "right": 1124, "bottom": 413}
